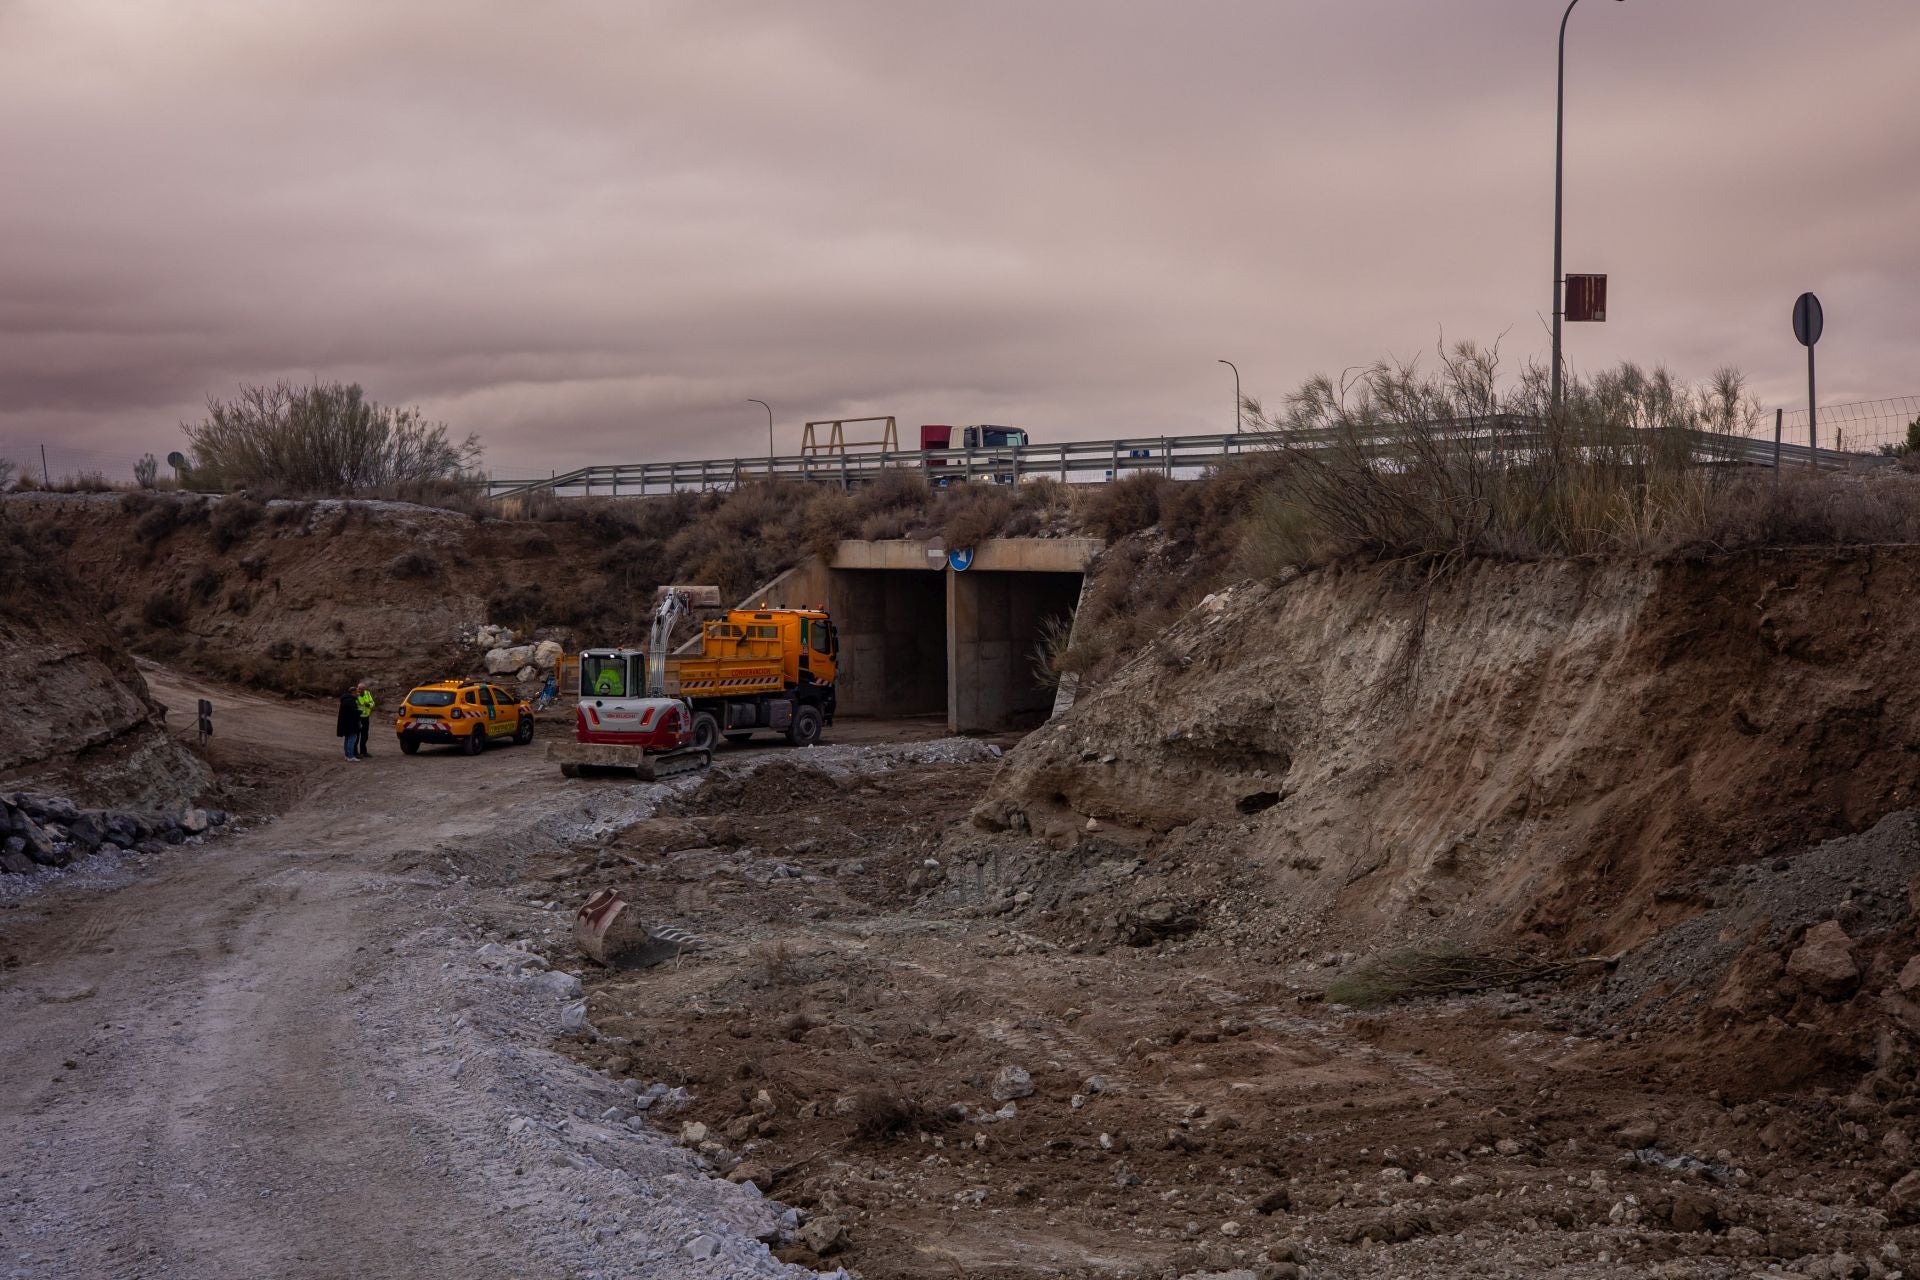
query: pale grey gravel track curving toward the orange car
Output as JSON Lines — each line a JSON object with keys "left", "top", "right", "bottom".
{"left": 0, "top": 674, "right": 825, "bottom": 1280}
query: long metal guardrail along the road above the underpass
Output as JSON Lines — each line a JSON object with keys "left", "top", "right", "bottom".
{"left": 486, "top": 415, "right": 1887, "bottom": 499}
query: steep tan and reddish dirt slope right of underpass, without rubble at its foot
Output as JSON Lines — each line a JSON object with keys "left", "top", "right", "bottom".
{"left": 977, "top": 547, "right": 1920, "bottom": 952}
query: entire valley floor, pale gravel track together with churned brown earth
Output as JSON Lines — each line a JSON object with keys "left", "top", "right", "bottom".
{"left": 0, "top": 672, "right": 1920, "bottom": 1280}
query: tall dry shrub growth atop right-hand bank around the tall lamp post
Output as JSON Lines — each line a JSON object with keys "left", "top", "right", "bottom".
{"left": 1250, "top": 344, "right": 1757, "bottom": 564}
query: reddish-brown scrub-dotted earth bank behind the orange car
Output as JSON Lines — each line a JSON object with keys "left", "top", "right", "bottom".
{"left": 8, "top": 495, "right": 614, "bottom": 697}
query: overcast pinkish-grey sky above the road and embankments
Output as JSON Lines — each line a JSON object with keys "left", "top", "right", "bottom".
{"left": 0, "top": 0, "right": 1920, "bottom": 476}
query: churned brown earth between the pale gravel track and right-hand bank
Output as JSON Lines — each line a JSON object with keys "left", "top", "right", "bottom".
{"left": 501, "top": 760, "right": 1920, "bottom": 1280}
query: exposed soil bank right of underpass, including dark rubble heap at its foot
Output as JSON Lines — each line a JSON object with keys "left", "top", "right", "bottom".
{"left": 967, "top": 547, "right": 1920, "bottom": 1077}
